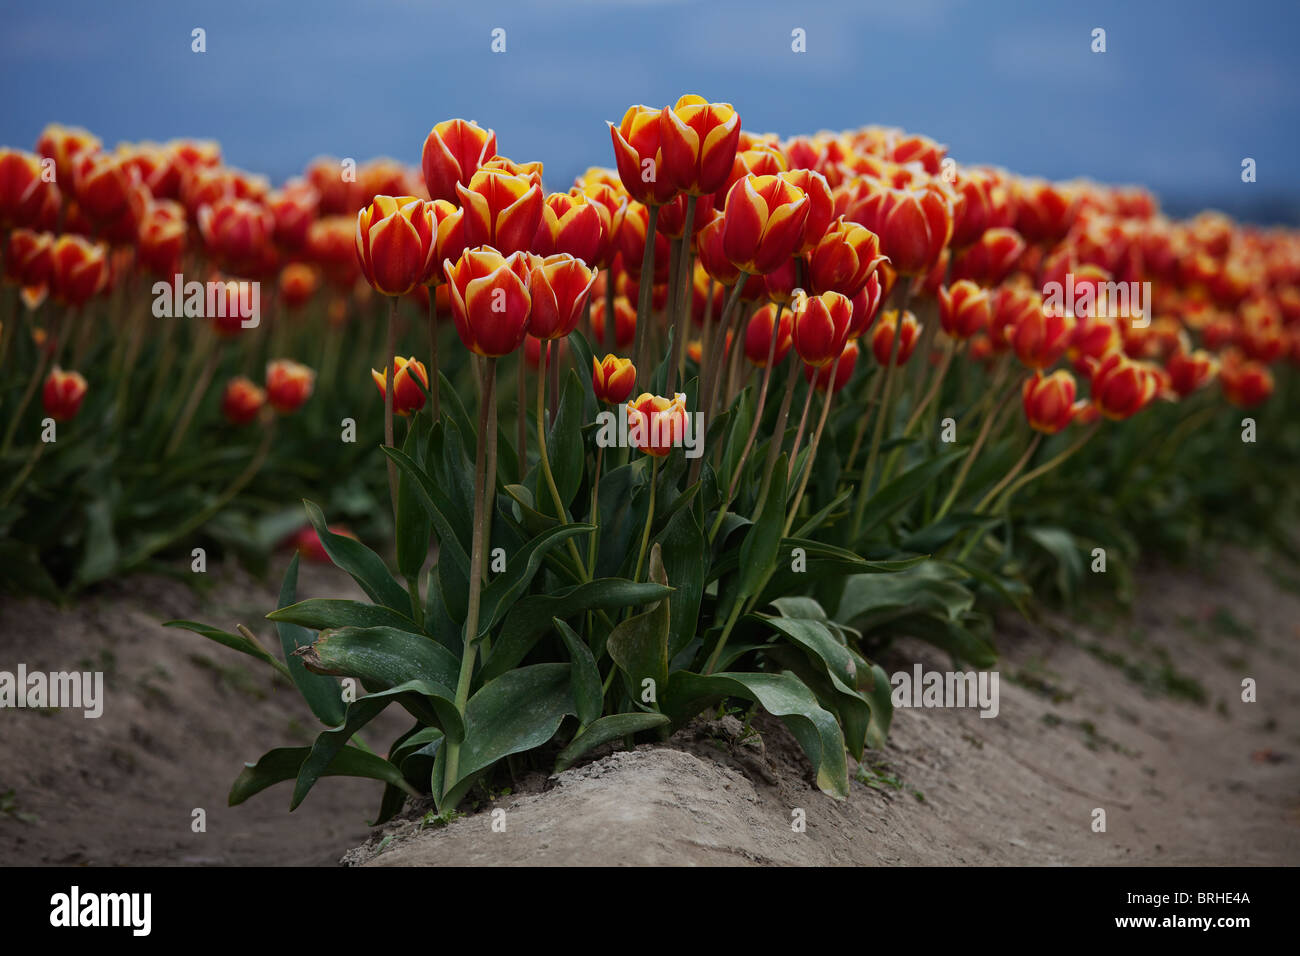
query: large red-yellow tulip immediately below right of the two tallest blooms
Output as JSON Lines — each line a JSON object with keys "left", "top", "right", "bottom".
{"left": 728, "top": 176, "right": 810, "bottom": 276}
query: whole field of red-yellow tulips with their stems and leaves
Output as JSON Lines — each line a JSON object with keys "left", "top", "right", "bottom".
{"left": 0, "top": 97, "right": 1300, "bottom": 822}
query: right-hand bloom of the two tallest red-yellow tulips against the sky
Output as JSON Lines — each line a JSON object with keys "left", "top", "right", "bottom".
{"left": 660, "top": 94, "right": 740, "bottom": 202}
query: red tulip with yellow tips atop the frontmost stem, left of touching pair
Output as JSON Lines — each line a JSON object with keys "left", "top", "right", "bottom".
{"left": 442, "top": 246, "right": 532, "bottom": 358}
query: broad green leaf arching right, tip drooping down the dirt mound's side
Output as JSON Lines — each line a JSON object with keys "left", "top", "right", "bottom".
{"left": 666, "top": 671, "right": 849, "bottom": 800}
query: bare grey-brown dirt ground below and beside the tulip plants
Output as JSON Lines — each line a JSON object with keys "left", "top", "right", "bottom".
{"left": 0, "top": 553, "right": 1300, "bottom": 865}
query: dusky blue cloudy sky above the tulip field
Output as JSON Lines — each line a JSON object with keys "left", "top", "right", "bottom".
{"left": 0, "top": 0, "right": 1300, "bottom": 221}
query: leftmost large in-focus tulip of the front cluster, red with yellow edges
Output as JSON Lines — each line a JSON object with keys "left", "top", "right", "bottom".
{"left": 355, "top": 196, "right": 436, "bottom": 295}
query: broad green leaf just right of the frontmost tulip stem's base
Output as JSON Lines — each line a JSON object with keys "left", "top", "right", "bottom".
{"left": 433, "top": 663, "right": 577, "bottom": 809}
